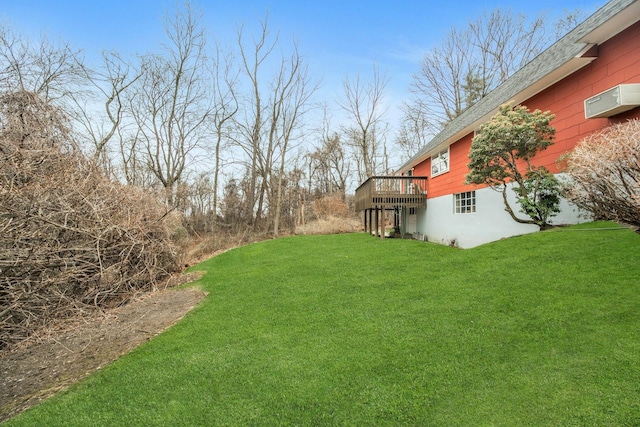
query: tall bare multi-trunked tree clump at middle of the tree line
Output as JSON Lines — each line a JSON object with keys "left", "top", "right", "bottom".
{"left": 235, "top": 17, "right": 315, "bottom": 235}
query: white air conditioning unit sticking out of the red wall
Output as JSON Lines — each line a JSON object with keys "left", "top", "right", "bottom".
{"left": 584, "top": 83, "right": 640, "bottom": 119}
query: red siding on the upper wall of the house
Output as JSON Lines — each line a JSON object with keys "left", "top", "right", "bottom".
{"left": 422, "top": 22, "right": 640, "bottom": 198}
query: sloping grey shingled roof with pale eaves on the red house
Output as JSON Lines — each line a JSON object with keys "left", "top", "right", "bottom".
{"left": 398, "top": 0, "right": 640, "bottom": 173}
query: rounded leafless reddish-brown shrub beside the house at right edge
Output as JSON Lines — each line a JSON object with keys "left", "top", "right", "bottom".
{"left": 567, "top": 120, "right": 640, "bottom": 226}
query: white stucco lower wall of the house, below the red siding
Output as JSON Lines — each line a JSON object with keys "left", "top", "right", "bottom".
{"left": 416, "top": 180, "right": 587, "bottom": 248}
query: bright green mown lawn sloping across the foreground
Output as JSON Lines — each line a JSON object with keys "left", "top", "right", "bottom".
{"left": 8, "top": 223, "right": 640, "bottom": 426}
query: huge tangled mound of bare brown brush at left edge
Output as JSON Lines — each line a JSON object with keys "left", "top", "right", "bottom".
{"left": 0, "top": 92, "right": 185, "bottom": 349}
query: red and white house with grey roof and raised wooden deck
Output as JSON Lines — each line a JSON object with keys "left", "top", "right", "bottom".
{"left": 356, "top": 0, "right": 640, "bottom": 248}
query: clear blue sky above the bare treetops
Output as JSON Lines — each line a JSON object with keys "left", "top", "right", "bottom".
{"left": 0, "top": 0, "right": 605, "bottom": 129}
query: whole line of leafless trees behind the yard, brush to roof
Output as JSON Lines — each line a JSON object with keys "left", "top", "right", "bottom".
{"left": 0, "top": 2, "right": 580, "bottom": 236}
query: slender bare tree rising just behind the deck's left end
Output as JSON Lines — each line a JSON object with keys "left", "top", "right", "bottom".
{"left": 339, "top": 66, "right": 389, "bottom": 181}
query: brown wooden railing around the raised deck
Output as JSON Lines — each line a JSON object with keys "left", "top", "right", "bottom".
{"left": 355, "top": 176, "right": 427, "bottom": 212}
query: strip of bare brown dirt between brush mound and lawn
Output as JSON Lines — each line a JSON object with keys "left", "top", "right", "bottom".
{"left": 0, "top": 273, "right": 206, "bottom": 422}
